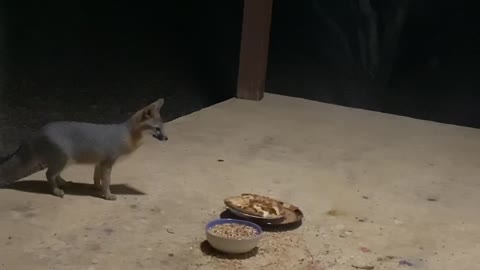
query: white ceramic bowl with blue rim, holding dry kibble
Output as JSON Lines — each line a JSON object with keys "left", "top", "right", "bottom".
{"left": 205, "top": 218, "right": 263, "bottom": 254}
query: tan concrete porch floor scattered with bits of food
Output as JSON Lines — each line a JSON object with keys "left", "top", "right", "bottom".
{"left": 0, "top": 94, "right": 480, "bottom": 270}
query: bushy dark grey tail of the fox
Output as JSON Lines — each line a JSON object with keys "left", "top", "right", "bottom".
{"left": 0, "top": 143, "right": 46, "bottom": 187}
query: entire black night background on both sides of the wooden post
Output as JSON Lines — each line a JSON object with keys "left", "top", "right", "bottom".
{"left": 0, "top": 0, "right": 480, "bottom": 152}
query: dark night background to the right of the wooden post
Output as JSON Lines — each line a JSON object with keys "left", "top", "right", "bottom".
{"left": 268, "top": 0, "right": 480, "bottom": 128}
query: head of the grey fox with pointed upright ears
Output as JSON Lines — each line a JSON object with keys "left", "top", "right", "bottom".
{"left": 130, "top": 98, "right": 168, "bottom": 141}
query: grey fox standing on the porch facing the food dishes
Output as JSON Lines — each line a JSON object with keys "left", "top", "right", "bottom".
{"left": 0, "top": 99, "right": 168, "bottom": 200}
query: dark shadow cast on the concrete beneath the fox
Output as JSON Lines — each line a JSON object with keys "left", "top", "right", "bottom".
{"left": 5, "top": 180, "right": 146, "bottom": 197}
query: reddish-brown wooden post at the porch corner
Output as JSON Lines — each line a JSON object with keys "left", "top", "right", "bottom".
{"left": 237, "top": 0, "right": 273, "bottom": 100}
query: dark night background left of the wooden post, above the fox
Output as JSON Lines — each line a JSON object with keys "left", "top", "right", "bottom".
{"left": 1, "top": 0, "right": 243, "bottom": 121}
